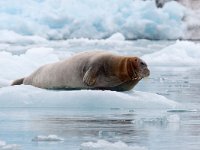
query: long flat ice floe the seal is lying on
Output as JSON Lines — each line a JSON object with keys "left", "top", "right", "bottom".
{"left": 0, "top": 85, "right": 180, "bottom": 110}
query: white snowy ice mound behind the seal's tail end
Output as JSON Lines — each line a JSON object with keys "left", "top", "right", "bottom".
{"left": 0, "top": 47, "right": 59, "bottom": 80}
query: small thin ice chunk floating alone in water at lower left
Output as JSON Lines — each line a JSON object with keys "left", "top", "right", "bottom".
{"left": 32, "top": 135, "right": 64, "bottom": 142}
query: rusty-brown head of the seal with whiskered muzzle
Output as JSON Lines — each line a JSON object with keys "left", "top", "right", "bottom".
{"left": 127, "top": 57, "right": 150, "bottom": 80}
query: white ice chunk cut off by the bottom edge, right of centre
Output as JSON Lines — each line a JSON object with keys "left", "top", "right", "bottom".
{"left": 81, "top": 140, "right": 148, "bottom": 150}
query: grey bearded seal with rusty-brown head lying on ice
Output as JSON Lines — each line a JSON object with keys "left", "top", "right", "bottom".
{"left": 12, "top": 51, "right": 150, "bottom": 91}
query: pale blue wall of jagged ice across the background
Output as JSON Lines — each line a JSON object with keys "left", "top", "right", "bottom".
{"left": 0, "top": 0, "right": 187, "bottom": 42}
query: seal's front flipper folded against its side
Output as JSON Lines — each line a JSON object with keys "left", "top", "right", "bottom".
{"left": 83, "top": 68, "right": 97, "bottom": 86}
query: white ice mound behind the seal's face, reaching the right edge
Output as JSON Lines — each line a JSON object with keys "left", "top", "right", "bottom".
{"left": 142, "top": 41, "right": 200, "bottom": 66}
